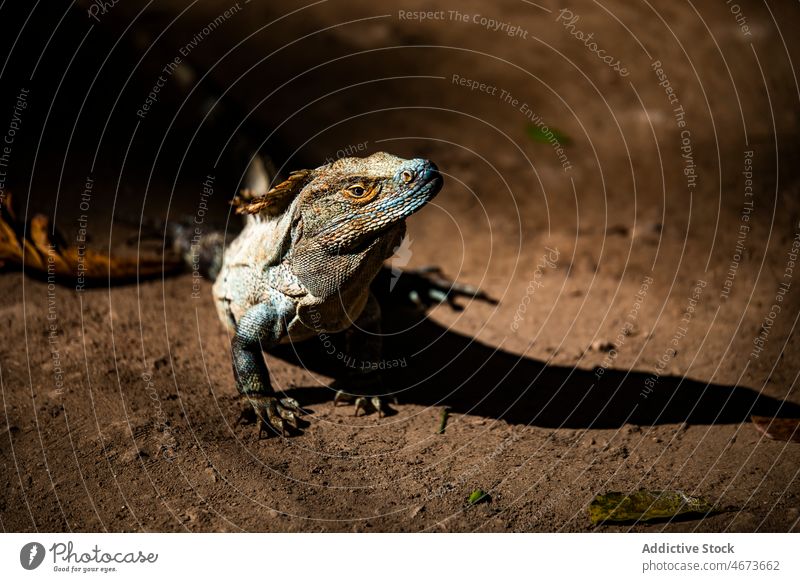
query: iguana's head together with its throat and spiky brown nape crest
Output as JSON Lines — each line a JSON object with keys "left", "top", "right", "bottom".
{"left": 234, "top": 153, "right": 443, "bottom": 298}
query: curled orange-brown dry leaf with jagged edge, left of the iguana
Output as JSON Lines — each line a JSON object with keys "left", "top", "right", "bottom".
{"left": 0, "top": 193, "right": 182, "bottom": 286}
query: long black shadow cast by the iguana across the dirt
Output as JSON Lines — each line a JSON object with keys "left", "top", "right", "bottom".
{"left": 271, "top": 269, "right": 800, "bottom": 429}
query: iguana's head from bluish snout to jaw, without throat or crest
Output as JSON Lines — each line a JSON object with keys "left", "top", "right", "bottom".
{"left": 297, "top": 152, "right": 443, "bottom": 250}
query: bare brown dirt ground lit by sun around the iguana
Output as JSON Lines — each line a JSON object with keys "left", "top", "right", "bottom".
{"left": 0, "top": 0, "right": 800, "bottom": 532}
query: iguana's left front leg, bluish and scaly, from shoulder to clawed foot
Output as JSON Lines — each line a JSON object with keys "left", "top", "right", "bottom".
{"left": 231, "top": 303, "right": 300, "bottom": 438}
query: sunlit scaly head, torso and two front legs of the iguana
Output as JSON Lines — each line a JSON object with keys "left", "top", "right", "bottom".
{"left": 213, "top": 153, "right": 442, "bottom": 436}
